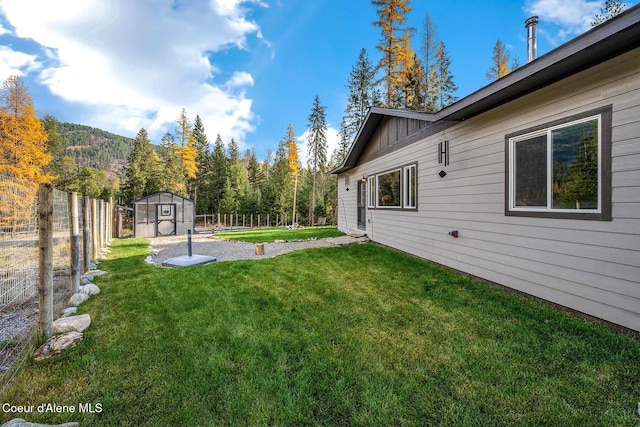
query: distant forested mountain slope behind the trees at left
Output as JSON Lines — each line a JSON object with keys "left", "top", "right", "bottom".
{"left": 58, "top": 123, "right": 133, "bottom": 177}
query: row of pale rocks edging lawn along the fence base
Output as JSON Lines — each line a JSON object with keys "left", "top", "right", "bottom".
{"left": 33, "top": 270, "right": 107, "bottom": 361}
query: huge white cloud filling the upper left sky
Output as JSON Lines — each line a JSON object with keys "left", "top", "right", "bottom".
{"left": 0, "top": 0, "right": 262, "bottom": 141}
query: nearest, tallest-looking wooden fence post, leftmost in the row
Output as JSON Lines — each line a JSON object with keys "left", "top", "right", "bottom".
{"left": 38, "top": 183, "right": 53, "bottom": 339}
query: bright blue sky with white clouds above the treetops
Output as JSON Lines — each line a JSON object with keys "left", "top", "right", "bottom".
{"left": 0, "top": 0, "right": 638, "bottom": 165}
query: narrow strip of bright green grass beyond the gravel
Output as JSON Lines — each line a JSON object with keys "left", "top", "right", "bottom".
{"left": 215, "top": 226, "right": 344, "bottom": 243}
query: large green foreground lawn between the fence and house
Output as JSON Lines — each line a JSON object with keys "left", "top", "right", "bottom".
{"left": 0, "top": 239, "right": 640, "bottom": 426}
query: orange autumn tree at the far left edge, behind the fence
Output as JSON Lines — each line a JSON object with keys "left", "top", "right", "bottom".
{"left": 0, "top": 76, "right": 52, "bottom": 183}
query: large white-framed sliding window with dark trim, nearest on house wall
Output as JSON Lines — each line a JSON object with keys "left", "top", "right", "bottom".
{"left": 507, "top": 107, "right": 611, "bottom": 219}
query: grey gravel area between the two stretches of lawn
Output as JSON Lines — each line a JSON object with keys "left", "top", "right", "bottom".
{"left": 147, "top": 234, "right": 366, "bottom": 266}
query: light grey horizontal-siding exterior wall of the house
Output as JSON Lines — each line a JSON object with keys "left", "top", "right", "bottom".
{"left": 338, "top": 49, "right": 640, "bottom": 331}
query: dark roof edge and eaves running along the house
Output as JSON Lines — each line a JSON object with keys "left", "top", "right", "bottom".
{"left": 329, "top": 5, "right": 640, "bottom": 174}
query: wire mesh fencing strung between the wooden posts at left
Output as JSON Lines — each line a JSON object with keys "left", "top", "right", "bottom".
{"left": 0, "top": 176, "right": 112, "bottom": 396}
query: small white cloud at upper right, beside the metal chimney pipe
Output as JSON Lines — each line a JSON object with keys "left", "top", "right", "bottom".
{"left": 525, "top": 0, "right": 604, "bottom": 45}
